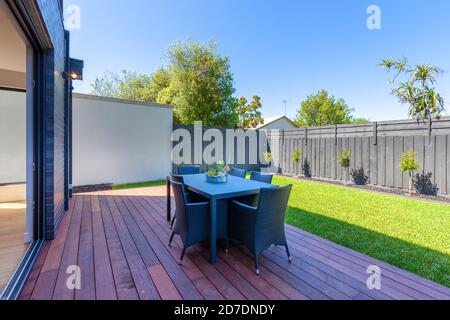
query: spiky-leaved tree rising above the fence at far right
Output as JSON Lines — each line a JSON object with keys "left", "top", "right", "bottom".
{"left": 379, "top": 59, "right": 445, "bottom": 120}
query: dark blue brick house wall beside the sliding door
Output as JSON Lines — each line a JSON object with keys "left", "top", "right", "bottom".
{"left": 38, "top": 0, "right": 66, "bottom": 239}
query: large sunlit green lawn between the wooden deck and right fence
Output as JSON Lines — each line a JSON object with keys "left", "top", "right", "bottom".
{"left": 274, "top": 177, "right": 450, "bottom": 287}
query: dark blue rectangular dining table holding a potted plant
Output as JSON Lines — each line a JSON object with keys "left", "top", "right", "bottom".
{"left": 168, "top": 174, "right": 275, "bottom": 264}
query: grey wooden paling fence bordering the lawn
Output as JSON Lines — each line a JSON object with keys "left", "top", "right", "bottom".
{"left": 172, "top": 118, "right": 450, "bottom": 195}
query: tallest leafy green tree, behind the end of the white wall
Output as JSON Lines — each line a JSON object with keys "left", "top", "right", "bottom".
{"left": 164, "top": 42, "right": 238, "bottom": 127}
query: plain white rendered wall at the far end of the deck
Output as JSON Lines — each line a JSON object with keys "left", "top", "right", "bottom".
{"left": 73, "top": 94, "right": 173, "bottom": 186}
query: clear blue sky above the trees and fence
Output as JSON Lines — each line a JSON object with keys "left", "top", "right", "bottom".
{"left": 65, "top": 0, "right": 450, "bottom": 120}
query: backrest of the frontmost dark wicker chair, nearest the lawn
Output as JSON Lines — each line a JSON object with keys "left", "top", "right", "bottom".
{"left": 256, "top": 185, "right": 292, "bottom": 228}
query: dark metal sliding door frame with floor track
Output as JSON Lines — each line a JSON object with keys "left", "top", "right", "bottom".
{"left": 0, "top": 0, "right": 46, "bottom": 300}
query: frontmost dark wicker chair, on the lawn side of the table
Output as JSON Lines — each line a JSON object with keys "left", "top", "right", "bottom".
{"left": 228, "top": 185, "right": 292, "bottom": 275}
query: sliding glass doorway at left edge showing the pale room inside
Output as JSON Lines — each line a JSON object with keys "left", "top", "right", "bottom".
{"left": 0, "top": 2, "right": 36, "bottom": 297}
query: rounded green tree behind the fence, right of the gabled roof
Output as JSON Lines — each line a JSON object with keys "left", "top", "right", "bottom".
{"left": 295, "top": 90, "right": 368, "bottom": 127}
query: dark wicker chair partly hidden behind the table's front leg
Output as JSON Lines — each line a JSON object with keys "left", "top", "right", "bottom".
{"left": 169, "top": 181, "right": 228, "bottom": 264}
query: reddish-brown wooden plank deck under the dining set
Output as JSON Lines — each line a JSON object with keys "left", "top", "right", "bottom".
{"left": 21, "top": 187, "right": 450, "bottom": 300}
